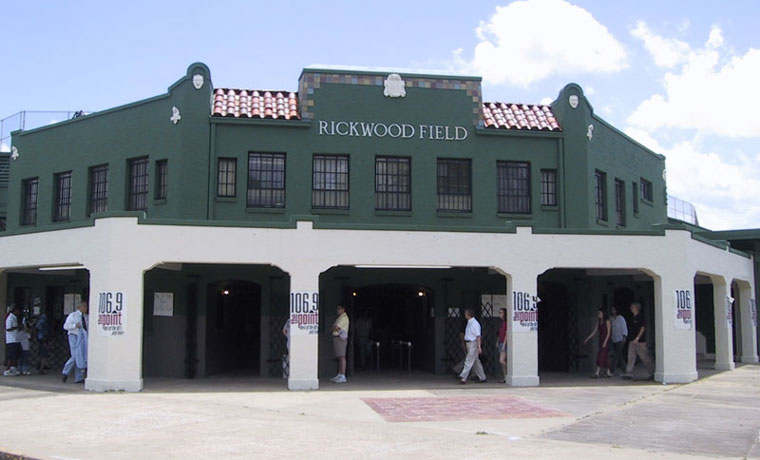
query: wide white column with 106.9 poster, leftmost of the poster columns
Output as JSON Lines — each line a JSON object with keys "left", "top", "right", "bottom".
{"left": 85, "top": 264, "right": 143, "bottom": 391}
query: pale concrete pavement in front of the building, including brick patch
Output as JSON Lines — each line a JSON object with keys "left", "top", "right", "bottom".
{"left": 0, "top": 365, "right": 760, "bottom": 460}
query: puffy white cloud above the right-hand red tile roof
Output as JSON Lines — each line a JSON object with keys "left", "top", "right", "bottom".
{"left": 454, "top": 0, "right": 627, "bottom": 87}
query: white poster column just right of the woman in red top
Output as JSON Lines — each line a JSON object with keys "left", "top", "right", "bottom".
{"left": 502, "top": 270, "right": 539, "bottom": 387}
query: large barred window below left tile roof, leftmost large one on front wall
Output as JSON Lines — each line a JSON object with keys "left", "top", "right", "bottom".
{"left": 247, "top": 153, "right": 285, "bottom": 208}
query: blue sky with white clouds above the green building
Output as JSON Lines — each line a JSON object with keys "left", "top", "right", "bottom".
{"left": 0, "top": 0, "right": 760, "bottom": 230}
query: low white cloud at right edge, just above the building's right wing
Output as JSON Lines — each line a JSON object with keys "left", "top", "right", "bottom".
{"left": 626, "top": 128, "right": 760, "bottom": 230}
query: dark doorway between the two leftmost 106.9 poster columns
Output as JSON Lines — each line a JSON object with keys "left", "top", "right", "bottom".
{"left": 206, "top": 281, "right": 261, "bottom": 375}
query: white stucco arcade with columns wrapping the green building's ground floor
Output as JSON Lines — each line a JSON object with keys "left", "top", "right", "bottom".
{"left": 0, "top": 217, "right": 758, "bottom": 391}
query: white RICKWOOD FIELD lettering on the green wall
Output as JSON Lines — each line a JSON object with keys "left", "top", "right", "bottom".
{"left": 317, "top": 120, "right": 469, "bottom": 141}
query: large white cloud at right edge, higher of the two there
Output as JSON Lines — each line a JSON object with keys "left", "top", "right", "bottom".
{"left": 628, "top": 23, "right": 760, "bottom": 137}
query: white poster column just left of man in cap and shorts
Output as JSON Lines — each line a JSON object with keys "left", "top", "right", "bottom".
{"left": 286, "top": 265, "right": 320, "bottom": 390}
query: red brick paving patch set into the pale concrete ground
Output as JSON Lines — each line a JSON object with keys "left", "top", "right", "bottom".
{"left": 362, "top": 396, "right": 567, "bottom": 422}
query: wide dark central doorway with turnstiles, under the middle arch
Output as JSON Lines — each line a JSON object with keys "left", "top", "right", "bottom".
{"left": 347, "top": 284, "right": 435, "bottom": 372}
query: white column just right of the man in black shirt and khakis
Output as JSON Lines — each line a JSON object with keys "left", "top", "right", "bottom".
{"left": 652, "top": 272, "right": 697, "bottom": 383}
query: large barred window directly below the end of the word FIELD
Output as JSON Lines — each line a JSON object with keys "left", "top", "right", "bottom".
{"left": 438, "top": 158, "right": 472, "bottom": 212}
